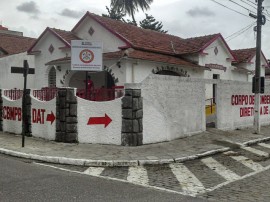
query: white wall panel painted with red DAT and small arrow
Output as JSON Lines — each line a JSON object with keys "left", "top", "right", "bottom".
{"left": 31, "top": 95, "right": 56, "bottom": 140}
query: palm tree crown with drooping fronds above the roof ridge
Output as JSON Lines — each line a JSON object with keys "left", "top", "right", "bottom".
{"left": 111, "top": 0, "right": 153, "bottom": 26}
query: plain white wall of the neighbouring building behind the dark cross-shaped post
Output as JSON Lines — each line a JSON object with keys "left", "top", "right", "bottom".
{"left": 0, "top": 52, "right": 35, "bottom": 89}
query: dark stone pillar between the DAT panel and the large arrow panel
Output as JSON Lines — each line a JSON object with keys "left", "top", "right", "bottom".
{"left": 56, "top": 88, "right": 78, "bottom": 143}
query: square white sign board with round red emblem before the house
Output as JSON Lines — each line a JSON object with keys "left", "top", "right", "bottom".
{"left": 71, "top": 40, "right": 103, "bottom": 71}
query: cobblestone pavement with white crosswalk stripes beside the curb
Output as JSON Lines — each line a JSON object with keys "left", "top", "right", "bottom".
{"left": 37, "top": 142, "right": 270, "bottom": 201}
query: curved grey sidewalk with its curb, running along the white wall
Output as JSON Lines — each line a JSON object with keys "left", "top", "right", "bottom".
{"left": 0, "top": 126, "right": 270, "bottom": 166}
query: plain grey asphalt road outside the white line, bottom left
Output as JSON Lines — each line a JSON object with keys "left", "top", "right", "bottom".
{"left": 0, "top": 155, "right": 203, "bottom": 202}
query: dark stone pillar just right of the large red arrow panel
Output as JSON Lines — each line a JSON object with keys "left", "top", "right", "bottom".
{"left": 122, "top": 89, "right": 143, "bottom": 146}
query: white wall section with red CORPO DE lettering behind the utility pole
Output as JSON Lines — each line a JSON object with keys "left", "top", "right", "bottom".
{"left": 216, "top": 81, "right": 270, "bottom": 130}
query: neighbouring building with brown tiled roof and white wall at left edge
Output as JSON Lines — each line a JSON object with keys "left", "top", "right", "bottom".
{"left": 0, "top": 26, "right": 35, "bottom": 89}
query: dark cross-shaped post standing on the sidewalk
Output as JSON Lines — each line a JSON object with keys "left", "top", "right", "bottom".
{"left": 11, "top": 60, "right": 35, "bottom": 147}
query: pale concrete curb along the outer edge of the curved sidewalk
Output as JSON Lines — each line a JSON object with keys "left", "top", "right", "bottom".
{"left": 0, "top": 137, "right": 270, "bottom": 167}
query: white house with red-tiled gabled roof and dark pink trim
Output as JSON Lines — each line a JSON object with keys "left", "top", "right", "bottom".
{"left": 1, "top": 12, "right": 268, "bottom": 98}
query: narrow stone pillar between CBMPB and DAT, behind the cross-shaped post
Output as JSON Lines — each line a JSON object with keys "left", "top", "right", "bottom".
{"left": 22, "top": 89, "right": 32, "bottom": 137}
